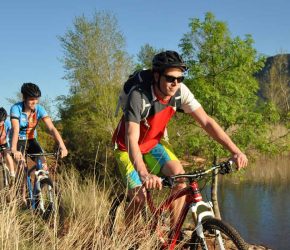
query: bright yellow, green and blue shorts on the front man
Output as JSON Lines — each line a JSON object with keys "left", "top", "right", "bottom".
{"left": 115, "top": 143, "right": 178, "bottom": 189}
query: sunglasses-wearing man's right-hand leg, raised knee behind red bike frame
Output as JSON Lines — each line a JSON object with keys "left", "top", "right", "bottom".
{"left": 144, "top": 143, "right": 185, "bottom": 227}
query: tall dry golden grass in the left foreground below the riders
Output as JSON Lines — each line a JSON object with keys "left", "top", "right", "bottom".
{"left": 0, "top": 165, "right": 161, "bottom": 250}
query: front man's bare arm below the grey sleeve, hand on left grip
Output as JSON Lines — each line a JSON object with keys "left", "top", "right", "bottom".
{"left": 125, "top": 122, "right": 162, "bottom": 189}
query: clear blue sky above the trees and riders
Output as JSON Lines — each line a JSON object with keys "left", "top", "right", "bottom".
{"left": 0, "top": 0, "right": 290, "bottom": 114}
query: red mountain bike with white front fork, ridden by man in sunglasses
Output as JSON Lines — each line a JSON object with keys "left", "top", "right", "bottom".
{"left": 109, "top": 160, "right": 248, "bottom": 250}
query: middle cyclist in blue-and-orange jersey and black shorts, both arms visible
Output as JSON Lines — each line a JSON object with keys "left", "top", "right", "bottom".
{"left": 10, "top": 83, "right": 68, "bottom": 204}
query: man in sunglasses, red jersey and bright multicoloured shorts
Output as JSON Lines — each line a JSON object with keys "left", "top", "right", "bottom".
{"left": 113, "top": 51, "right": 248, "bottom": 230}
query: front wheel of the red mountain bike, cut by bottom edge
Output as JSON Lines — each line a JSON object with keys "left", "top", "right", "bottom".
{"left": 189, "top": 218, "right": 249, "bottom": 250}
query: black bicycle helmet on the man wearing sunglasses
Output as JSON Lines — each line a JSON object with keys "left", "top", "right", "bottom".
{"left": 152, "top": 50, "right": 187, "bottom": 72}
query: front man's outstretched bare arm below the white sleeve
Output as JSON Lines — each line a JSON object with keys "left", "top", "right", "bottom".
{"left": 191, "top": 107, "right": 248, "bottom": 169}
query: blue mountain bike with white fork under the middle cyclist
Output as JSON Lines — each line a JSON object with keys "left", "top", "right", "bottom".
{"left": 24, "top": 153, "right": 64, "bottom": 222}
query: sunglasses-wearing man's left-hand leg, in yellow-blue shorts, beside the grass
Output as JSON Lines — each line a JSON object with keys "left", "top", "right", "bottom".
{"left": 115, "top": 150, "right": 146, "bottom": 227}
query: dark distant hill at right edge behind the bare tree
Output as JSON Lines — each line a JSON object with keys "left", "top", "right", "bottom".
{"left": 255, "top": 54, "right": 290, "bottom": 99}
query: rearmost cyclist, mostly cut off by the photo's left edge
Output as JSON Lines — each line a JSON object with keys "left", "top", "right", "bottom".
{"left": 0, "top": 107, "right": 15, "bottom": 183}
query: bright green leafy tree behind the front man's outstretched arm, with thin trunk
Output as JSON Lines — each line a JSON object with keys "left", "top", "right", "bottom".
{"left": 180, "top": 13, "right": 267, "bottom": 216}
